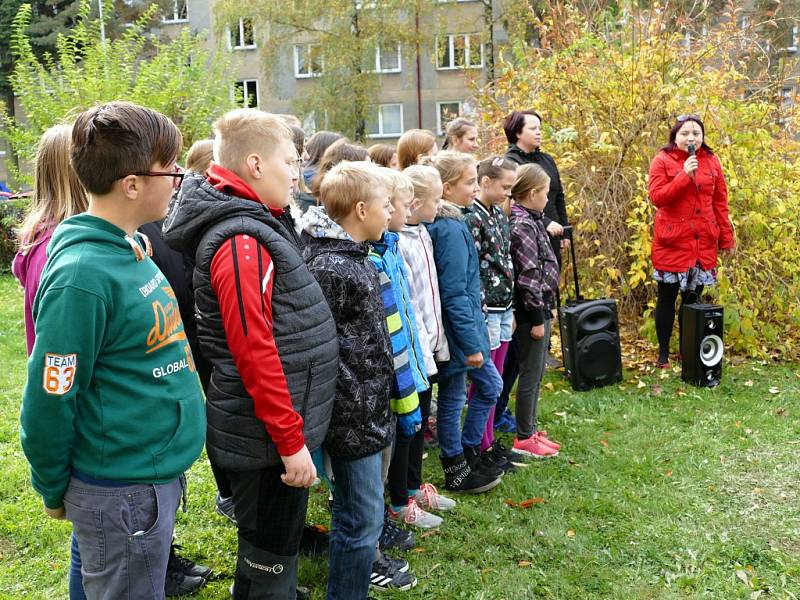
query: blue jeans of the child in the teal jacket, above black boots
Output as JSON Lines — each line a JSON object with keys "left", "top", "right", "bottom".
{"left": 436, "top": 360, "right": 503, "bottom": 458}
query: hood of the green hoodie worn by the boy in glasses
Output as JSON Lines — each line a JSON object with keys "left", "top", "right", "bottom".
{"left": 48, "top": 213, "right": 151, "bottom": 260}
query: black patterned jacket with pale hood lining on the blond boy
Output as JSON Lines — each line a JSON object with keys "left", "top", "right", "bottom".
{"left": 302, "top": 206, "right": 394, "bottom": 458}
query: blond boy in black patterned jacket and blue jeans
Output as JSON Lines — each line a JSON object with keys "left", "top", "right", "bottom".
{"left": 303, "top": 161, "right": 416, "bottom": 600}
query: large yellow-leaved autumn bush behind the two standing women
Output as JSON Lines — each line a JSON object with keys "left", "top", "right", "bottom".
{"left": 478, "top": 4, "right": 800, "bottom": 358}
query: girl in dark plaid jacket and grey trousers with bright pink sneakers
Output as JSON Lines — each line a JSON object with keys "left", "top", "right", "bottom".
{"left": 511, "top": 164, "right": 560, "bottom": 458}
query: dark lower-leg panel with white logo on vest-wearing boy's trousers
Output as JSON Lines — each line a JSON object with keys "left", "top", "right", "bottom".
{"left": 233, "top": 536, "right": 297, "bottom": 600}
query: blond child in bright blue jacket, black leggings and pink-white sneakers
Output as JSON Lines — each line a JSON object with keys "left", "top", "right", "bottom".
{"left": 370, "top": 172, "right": 455, "bottom": 529}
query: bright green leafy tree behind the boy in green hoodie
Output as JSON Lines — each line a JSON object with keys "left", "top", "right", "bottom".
{"left": 0, "top": 0, "right": 234, "bottom": 180}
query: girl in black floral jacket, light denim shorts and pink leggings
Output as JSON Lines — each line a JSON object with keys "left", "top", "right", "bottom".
{"left": 465, "top": 156, "right": 524, "bottom": 471}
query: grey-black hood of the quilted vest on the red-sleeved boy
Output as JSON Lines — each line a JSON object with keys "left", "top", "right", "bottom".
{"left": 164, "top": 173, "right": 284, "bottom": 255}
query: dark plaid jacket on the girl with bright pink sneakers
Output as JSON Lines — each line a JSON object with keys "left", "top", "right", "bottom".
{"left": 511, "top": 204, "right": 559, "bottom": 325}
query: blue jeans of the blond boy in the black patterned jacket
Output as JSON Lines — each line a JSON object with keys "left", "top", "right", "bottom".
{"left": 327, "top": 452, "right": 383, "bottom": 600}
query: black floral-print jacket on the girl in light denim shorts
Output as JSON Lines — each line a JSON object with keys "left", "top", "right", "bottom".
{"left": 464, "top": 200, "right": 514, "bottom": 312}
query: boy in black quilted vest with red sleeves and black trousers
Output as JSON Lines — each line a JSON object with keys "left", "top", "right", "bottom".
{"left": 164, "top": 109, "right": 338, "bottom": 600}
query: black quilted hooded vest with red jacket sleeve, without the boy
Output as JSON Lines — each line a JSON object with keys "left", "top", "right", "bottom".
{"left": 164, "top": 164, "right": 338, "bottom": 471}
